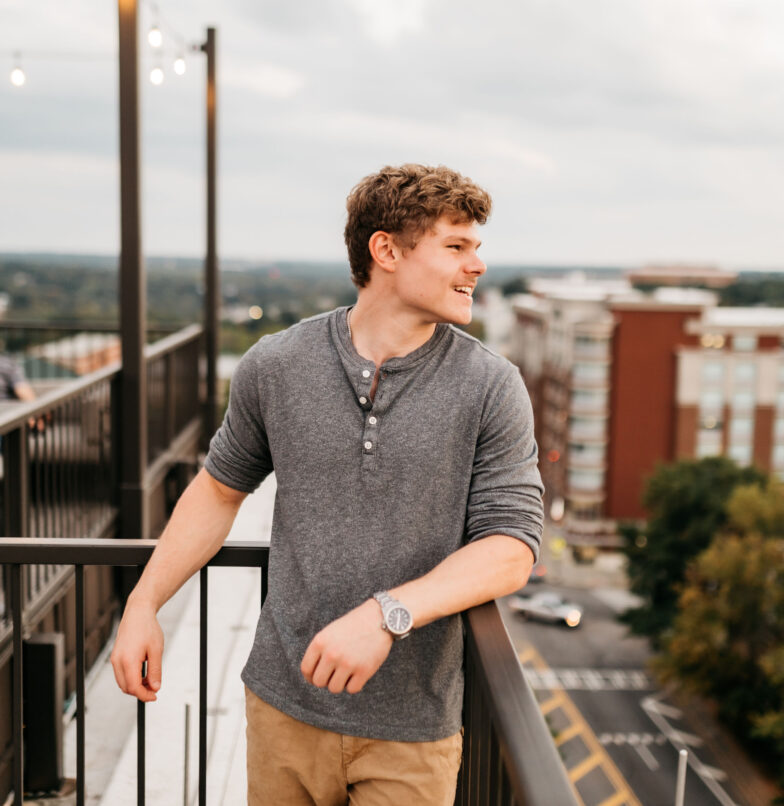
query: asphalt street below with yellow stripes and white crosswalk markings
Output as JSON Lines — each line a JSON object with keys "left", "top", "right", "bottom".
{"left": 501, "top": 584, "right": 747, "bottom": 806}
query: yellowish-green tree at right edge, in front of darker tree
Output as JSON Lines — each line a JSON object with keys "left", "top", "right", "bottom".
{"left": 656, "top": 481, "right": 784, "bottom": 783}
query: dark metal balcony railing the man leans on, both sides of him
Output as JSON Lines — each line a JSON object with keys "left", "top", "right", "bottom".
{"left": 0, "top": 538, "right": 577, "bottom": 806}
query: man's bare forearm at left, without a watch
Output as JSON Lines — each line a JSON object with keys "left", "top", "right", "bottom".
{"left": 129, "top": 470, "right": 245, "bottom": 611}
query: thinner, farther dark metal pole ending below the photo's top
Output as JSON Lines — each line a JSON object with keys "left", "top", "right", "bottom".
{"left": 202, "top": 28, "right": 220, "bottom": 440}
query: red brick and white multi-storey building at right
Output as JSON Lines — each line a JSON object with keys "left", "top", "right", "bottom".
{"left": 510, "top": 274, "right": 784, "bottom": 548}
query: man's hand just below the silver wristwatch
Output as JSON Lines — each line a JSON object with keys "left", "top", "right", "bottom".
{"left": 300, "top": 599, "right": 393, "bottom": 694}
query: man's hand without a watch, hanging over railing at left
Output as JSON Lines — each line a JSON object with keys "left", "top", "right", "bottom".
{"left": 111, "top": 599, "right": 163, "bottom": 702}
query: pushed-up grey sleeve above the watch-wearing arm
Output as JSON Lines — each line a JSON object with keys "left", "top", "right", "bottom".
{"left": 466, "top": 366, "right": 544, "bottom": 559}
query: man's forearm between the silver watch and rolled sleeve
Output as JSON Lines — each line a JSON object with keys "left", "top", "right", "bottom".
{"left": 390, "top": 535, "right": 534, "bottom": 628}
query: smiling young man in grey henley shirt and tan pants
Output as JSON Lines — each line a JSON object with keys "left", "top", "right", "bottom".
{"left": 112, "top": 165, "right": 542, "bottom": 806}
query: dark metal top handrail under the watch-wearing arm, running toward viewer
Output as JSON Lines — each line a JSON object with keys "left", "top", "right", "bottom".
{"left": 463, "top": 602, "right": 577, "bottom": 806}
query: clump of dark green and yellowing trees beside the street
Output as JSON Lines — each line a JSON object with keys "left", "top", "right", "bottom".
{"left": 622, "top": 457, "right": 784, "bottom": 786}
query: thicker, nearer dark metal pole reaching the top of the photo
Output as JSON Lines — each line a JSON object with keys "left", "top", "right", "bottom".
{"left": 118, "top": 0, "right": 149, "bottom": 538}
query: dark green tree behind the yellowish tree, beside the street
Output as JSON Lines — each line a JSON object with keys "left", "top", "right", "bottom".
{"left": 620, "top": 456, "right": 765, "bottom": 643}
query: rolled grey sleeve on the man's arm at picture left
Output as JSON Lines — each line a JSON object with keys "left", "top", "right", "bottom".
{"left": 204, "top": 345, "right": 273, "bottom": 492}
